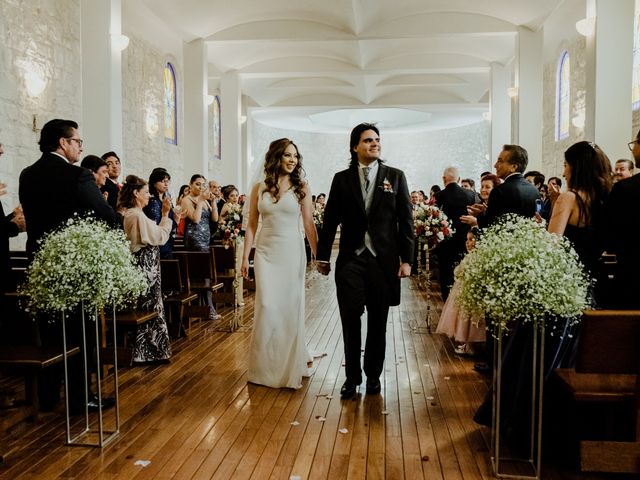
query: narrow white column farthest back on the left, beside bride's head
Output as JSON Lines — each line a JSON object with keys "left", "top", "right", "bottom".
{"left": 219, "top": 71, "right": 243, "bottom": 186}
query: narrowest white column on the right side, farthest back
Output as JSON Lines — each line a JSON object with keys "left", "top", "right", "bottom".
{"left": 489, "top": 62, "right": 511, "bottom": 165}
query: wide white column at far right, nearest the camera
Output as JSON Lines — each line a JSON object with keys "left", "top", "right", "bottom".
{"left": 585, "top": 0, "right": 635, "bottom": 161}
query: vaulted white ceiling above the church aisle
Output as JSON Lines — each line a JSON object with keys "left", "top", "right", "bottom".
{"left": 123, "top": 0, "right": 562, "bottom": 130}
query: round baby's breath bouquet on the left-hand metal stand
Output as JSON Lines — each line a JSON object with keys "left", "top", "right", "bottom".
{"left": 21, "top": 217, "right": 148, "bottom": 312}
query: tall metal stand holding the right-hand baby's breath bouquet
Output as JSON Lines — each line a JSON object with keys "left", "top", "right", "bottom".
{"left": 491, "top": 323, "right": 544, "bottom": 480}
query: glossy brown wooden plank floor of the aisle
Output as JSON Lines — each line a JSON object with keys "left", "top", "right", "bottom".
{"left": 0, "top": 266, "right": 632, "bottom": 480}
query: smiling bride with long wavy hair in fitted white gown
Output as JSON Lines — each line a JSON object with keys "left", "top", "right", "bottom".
{"left": 242, "top": 138, "right": 318, "bottom": 388}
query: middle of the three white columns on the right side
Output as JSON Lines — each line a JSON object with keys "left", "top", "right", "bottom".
{"left": 514, "top": 27, "right": 543, "bottom": 170}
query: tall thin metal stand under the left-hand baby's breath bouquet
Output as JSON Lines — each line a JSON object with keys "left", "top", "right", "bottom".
{"left": 62, "top": 304, "right": 120, "bottom": 447}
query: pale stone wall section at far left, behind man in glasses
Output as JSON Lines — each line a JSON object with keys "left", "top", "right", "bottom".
{"left": 0, "top": 0, "right": 82, "bottom": 249}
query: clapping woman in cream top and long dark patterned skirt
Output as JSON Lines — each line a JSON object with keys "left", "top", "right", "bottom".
{"left": 118, "top": 175, "right": 173, "bottom": 363}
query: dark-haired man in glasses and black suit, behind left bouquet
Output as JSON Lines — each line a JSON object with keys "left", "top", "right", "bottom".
{"left": 19, "top": 119, "right": 119, "bottom": 413}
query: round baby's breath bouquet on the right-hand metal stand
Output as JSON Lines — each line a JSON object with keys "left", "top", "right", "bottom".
{"left": 456, "top": 214, "right": 591, "bottom": 337}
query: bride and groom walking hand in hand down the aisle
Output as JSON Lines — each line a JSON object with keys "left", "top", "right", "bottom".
{"left": 242, "top": 123, "right": 414, "bottom": 399}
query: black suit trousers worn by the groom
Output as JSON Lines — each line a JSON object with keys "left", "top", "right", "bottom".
{"left": 336, "top": 250, "right": 389, "bottom": 385}
